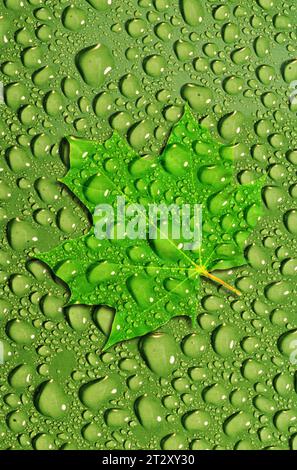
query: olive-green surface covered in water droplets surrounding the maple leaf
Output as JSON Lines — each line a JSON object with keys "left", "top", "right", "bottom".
{"left": 0, "top": 0, "right": 297, "bottom": 449}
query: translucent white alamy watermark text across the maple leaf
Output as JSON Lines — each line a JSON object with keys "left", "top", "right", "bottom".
{"left": 94, "top": 196, "right": 202, "bottom": 251}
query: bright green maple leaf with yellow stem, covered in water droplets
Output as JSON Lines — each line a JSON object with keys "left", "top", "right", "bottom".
{"left": 39, "top": 108, "right": 263, "bottom": 349}
